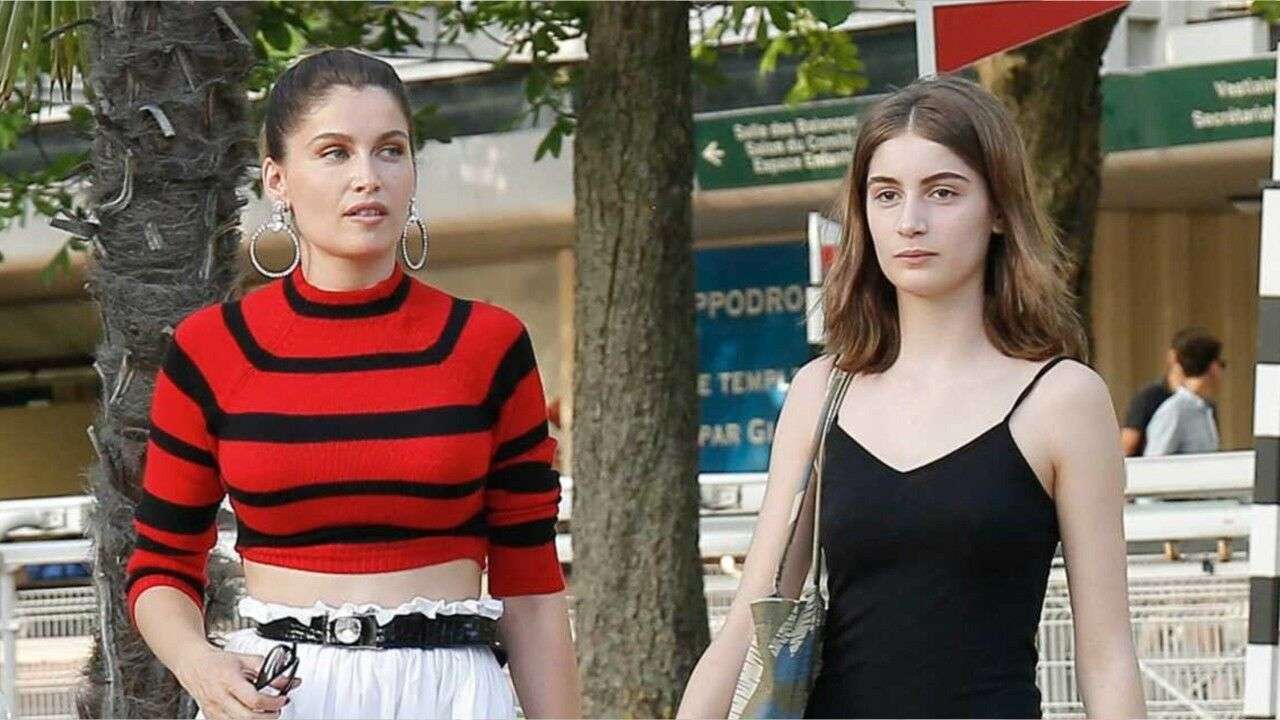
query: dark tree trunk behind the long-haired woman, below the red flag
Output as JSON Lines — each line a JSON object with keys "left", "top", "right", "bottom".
{"left": 977, "top": 12, "right": 1120, "bottom": 346}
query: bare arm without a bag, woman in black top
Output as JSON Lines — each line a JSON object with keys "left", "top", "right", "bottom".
{"left": 1033, "top": 364, "right": 1147, "bottom": 717}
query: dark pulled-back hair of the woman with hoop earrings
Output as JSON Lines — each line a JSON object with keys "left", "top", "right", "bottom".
{"left": 259, "top": 47, "right": 416, "bottom": 160}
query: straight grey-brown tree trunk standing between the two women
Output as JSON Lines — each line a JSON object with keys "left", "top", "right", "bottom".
{"left": 573, "top": 3, "right": 708, "bottom": 717}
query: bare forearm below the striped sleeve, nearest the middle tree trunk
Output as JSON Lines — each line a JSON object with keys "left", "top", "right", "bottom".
{"left": 498, "top": 593, "right": 582, "bottom": 717}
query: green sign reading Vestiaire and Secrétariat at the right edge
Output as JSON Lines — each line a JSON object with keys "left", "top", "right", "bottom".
{"left": 1102, "top": 56, "right": 1276, "bottom": 151}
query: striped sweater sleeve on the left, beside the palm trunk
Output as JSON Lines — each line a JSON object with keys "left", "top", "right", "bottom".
{"left": 125, "top": 317, "right": 224, "bottom": 626}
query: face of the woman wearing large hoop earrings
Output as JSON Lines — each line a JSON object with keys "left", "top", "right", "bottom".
{"left": 262, "top": 86, "right": 416, "bottom": 261}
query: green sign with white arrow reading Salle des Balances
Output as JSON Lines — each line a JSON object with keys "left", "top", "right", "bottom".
{"left": 694, "top": 96, "right": 878, "bottom": 190}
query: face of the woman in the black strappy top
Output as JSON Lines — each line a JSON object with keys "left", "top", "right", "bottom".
{"left": 864, "top": 132, "right": 1001, "bottom": 297}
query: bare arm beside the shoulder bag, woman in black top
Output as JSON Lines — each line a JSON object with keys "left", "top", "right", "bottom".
{"left": 677, "top": 356, "right": 831, "bottom": 717}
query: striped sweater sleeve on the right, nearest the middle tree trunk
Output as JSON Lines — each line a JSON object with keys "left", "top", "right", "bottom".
{"left": 485, "top": 327, "right": 564, "bottom": 597}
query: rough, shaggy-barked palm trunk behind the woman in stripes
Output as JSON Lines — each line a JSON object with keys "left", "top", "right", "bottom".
{"left": 79, "top": 1, "right": 255, "bottom": 717}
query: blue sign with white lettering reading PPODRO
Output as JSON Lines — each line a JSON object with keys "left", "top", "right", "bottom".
{"left": 694, "top": 242, "right": 810, "bottom": 473}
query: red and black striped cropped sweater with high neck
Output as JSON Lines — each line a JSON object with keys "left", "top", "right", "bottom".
{"left": 125, "top": 265, "right": 564, "bottom": 618}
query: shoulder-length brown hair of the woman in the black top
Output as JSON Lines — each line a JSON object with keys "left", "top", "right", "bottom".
{"left": 823, "top": 77, "right": 1087, "bottom": 373}
